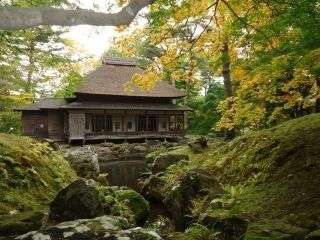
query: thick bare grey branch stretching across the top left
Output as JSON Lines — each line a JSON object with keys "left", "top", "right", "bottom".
{"left": 0, "top": 0, "right": 156, "bottom": 30}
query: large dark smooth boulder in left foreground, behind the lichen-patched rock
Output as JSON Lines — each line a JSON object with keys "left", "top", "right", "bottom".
{"left": 50, "top": 179, "right": 104, "bottom": 222}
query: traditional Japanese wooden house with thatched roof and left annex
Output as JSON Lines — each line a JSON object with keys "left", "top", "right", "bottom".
{"left": 17, "top": 58, "right": 191, "bottom": 142}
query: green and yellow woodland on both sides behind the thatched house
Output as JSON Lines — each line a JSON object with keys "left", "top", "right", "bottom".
{"left": 0, "top": 0, "right": 320, "bottom": 138}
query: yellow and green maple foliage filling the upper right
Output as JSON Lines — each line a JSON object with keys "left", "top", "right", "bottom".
{"left": 110, "top": 0, "right": 319, "bottom": 137}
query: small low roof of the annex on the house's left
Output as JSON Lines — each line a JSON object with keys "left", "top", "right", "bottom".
{"left": 15, "top": 98, "right": 68, "bottom": 111}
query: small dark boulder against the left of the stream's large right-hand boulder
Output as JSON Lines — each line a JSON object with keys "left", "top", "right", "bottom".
{"left": 141, "top": 175, "right": 165, "bottom": 203}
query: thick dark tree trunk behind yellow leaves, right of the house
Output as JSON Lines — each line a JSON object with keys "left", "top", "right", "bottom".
{"left": 221, "top": 43, "right": 236, "bottom": 140}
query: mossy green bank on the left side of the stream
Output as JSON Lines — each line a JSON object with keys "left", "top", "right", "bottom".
{"left": 0, "top": 134, "right": 76, "bottom": 215}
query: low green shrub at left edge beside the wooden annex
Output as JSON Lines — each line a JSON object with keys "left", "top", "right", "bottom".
{"left": 0, "top": 111, "right": 21, "bottom": 133}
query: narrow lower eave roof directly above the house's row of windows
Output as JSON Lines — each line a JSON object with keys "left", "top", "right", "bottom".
{"left": 61, "top": 102, "right": 192, "bottom": 111}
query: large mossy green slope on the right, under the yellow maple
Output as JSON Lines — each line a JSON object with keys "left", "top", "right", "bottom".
{"left": 163, "top": 114, "right": 320, "bottom": 228}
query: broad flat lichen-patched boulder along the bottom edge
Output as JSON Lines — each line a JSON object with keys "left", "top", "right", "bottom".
{"left": 16, "top": 216, "right": 162, "bottom": 240}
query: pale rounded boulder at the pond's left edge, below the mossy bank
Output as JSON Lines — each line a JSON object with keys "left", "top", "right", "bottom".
{"left": 64, "top": 146, "right": 100, "bottom": 179}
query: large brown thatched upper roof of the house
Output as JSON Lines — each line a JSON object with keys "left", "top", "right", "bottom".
{"left": 76, "top": 59, "right": 185, "bottom": 98}
